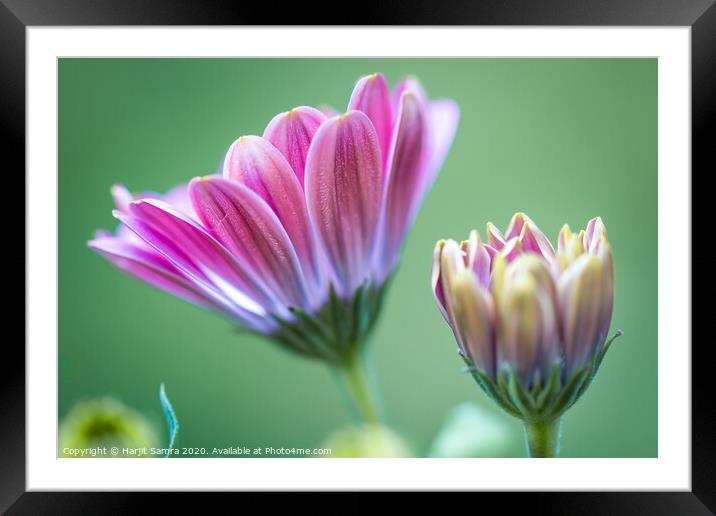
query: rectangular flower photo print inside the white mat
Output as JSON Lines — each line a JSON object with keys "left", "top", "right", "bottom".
{"left": 57, "top": 58, "right": 659, "bottom": 459}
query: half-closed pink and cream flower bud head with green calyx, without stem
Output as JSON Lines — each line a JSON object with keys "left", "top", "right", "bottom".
{"left": 432, "top": 213, "right": 614, "bottom": 419}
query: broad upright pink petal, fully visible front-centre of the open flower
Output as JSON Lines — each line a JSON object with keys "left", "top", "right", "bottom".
{"left": 306, "top": 111, "right": 383, "bottom": 296}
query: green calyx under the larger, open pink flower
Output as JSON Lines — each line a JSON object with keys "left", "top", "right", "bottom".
{"left": 270, "top": 281, "right": 388, "bottom": 365}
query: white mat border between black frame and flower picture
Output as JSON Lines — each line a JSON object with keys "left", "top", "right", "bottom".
{"left": 26, "top": 27, "right": 691, "bottom": 491}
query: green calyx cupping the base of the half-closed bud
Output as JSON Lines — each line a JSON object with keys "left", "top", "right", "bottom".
{"left": 463, "top": 331, "right": 621, "bottom": 423}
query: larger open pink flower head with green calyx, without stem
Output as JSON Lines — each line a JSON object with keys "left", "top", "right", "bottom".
{"left": 89, "top": 74, "right": 458, "bottom": 358}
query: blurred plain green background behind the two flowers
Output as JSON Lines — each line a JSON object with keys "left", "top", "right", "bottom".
{"left": 58, "top": 59, "right": 657, "bottom": 457}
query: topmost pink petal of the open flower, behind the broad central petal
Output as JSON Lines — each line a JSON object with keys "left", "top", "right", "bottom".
{"left": 348, "top": 73, "right": 393, "bottom": 164}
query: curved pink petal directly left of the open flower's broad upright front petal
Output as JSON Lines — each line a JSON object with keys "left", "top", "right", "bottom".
{"left": 217, "top": 136, "right": 325, "bottom": 303}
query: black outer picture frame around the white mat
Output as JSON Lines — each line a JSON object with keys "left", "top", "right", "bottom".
{"left": 0, "top": 0, "right": 716, "bottom": 515}
